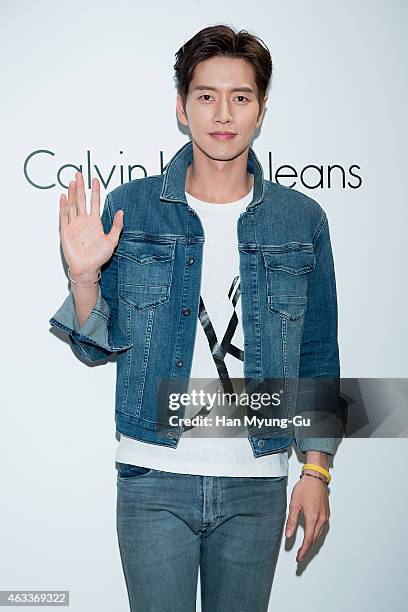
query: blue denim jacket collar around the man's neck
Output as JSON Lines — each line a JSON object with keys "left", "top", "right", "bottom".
{"left": 160, "top": 141, "right": 265, "bottom": 210}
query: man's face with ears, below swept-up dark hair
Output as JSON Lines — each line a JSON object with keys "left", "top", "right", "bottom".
{"left": 177, "top": 57, "right": 268, "bottom": 161}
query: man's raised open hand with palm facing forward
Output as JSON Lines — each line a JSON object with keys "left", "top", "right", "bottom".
{"left": 59, "top": 172, "right": 123, "bottom": 278}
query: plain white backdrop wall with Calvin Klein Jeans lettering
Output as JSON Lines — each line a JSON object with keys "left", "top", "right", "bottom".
{"left": 0, "top": 0, "right": 408, "bottom": 612}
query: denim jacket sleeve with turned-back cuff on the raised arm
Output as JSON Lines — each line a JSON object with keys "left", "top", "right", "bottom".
{"left": 49, "top": 194, "right": 133, "bottom": 362}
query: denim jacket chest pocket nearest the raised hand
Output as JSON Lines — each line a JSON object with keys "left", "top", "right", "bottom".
{"left": 116, "top": 238, "right": 175, "bottom": 309}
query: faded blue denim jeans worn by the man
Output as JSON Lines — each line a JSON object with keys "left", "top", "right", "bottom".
{"left": 116, "top": 463, "right": 288, "bottom": 612}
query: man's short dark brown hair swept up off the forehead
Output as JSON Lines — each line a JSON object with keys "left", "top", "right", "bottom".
{"left": 174, "top": 24, "right": 273, "bottom": 115}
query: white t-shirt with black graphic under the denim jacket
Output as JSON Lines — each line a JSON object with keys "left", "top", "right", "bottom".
{"left": 116, "top": 182, "right": 288, "bottom": 476}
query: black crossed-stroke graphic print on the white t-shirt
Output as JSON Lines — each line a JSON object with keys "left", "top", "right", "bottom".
{"left": 183, "top": 275, "right": 244, "bottom": 431}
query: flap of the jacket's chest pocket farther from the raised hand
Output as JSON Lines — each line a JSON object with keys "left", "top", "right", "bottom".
{"left": 262, "top": 243, "right": 316, "bottom": 274}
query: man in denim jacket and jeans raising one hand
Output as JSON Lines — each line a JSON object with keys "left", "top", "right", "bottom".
{"left": 50, "top": 25, "right": 339, "bottom": 612}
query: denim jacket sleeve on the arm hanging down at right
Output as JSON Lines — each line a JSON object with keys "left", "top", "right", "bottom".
{"left": 295, "top": 212, "right": 344, "bottom": 455}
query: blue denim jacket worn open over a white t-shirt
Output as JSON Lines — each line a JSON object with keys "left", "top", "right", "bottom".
{"left": 49, "top": 142, "right": 340, "bottom": 457}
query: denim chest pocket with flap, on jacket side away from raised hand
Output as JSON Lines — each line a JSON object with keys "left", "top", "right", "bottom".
{"left": 262, "top": 242, "right": 316, "bottom": 321}
